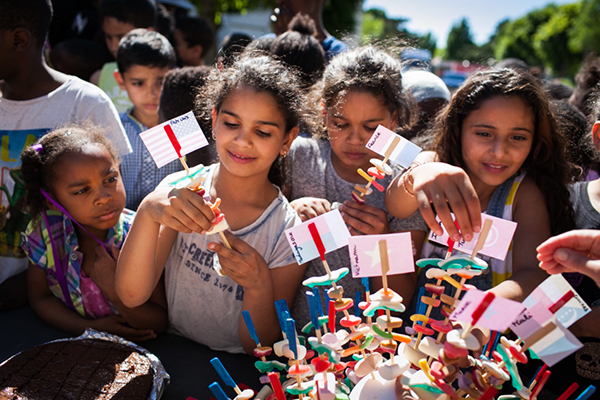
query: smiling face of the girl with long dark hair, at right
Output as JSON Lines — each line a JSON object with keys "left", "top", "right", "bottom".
{"left": 461, "top": 96, "right": 535, "bottom": 195}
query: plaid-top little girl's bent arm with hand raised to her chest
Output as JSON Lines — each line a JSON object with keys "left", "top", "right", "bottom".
{"left": 90, "top": 245, "right": 168, "bottom": 333}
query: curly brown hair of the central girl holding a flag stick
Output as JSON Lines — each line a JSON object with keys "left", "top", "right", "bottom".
{"left": 195, "top": 52, "right": 319, "bottom": 186}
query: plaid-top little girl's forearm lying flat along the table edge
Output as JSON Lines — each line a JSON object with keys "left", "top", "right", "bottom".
{"left": 27, "top": 264, "right": 156, "bottom": 342}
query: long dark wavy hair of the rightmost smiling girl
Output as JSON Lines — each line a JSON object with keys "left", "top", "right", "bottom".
{"left": 435, "top": 69, "right": 574, "bottom": 235}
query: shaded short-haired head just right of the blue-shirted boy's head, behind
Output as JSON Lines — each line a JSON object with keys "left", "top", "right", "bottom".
{"left": 173, "top": 17, "right": 215, "bottom": 67}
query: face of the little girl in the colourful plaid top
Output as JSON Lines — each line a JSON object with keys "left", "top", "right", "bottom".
{"left": 52, "top": 144, "right": 125, "bottom": 236}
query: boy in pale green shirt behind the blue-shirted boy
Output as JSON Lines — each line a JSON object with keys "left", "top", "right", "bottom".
{"left": 90, "top": 0, "right": 157, "bottom": 113}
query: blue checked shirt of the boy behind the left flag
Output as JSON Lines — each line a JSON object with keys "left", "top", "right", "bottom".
{"left": 120, "top": 110, "right": 183, "bottom": 210}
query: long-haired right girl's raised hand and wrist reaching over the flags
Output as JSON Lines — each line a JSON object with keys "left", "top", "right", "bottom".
{"left": 385, "top": 162, "right": 481, "bottom": 241}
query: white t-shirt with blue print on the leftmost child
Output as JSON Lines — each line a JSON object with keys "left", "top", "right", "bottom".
{"left": 0, "top": 75, "right": 131, "bottom": 283}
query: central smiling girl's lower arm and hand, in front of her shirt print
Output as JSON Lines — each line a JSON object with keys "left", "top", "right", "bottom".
{"left": 208, "top": 232, "right": 305, "bottom": 354}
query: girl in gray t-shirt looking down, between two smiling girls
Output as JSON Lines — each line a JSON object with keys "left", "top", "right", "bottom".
{"left": 286, "top": 46, "right": 426, "bottom": 327}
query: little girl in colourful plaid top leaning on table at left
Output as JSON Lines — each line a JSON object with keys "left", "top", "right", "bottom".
{"left": 21, "top": 126, "right": 167, "bottom": 341}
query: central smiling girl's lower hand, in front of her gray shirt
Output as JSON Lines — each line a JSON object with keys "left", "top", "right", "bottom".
{"left": 208, "top": 231, "right": 271, "bottom": 290}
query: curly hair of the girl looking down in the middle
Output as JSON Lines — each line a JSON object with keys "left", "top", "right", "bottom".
{"left": 316, "top": 46, "right": 418, "bottom": 137}
